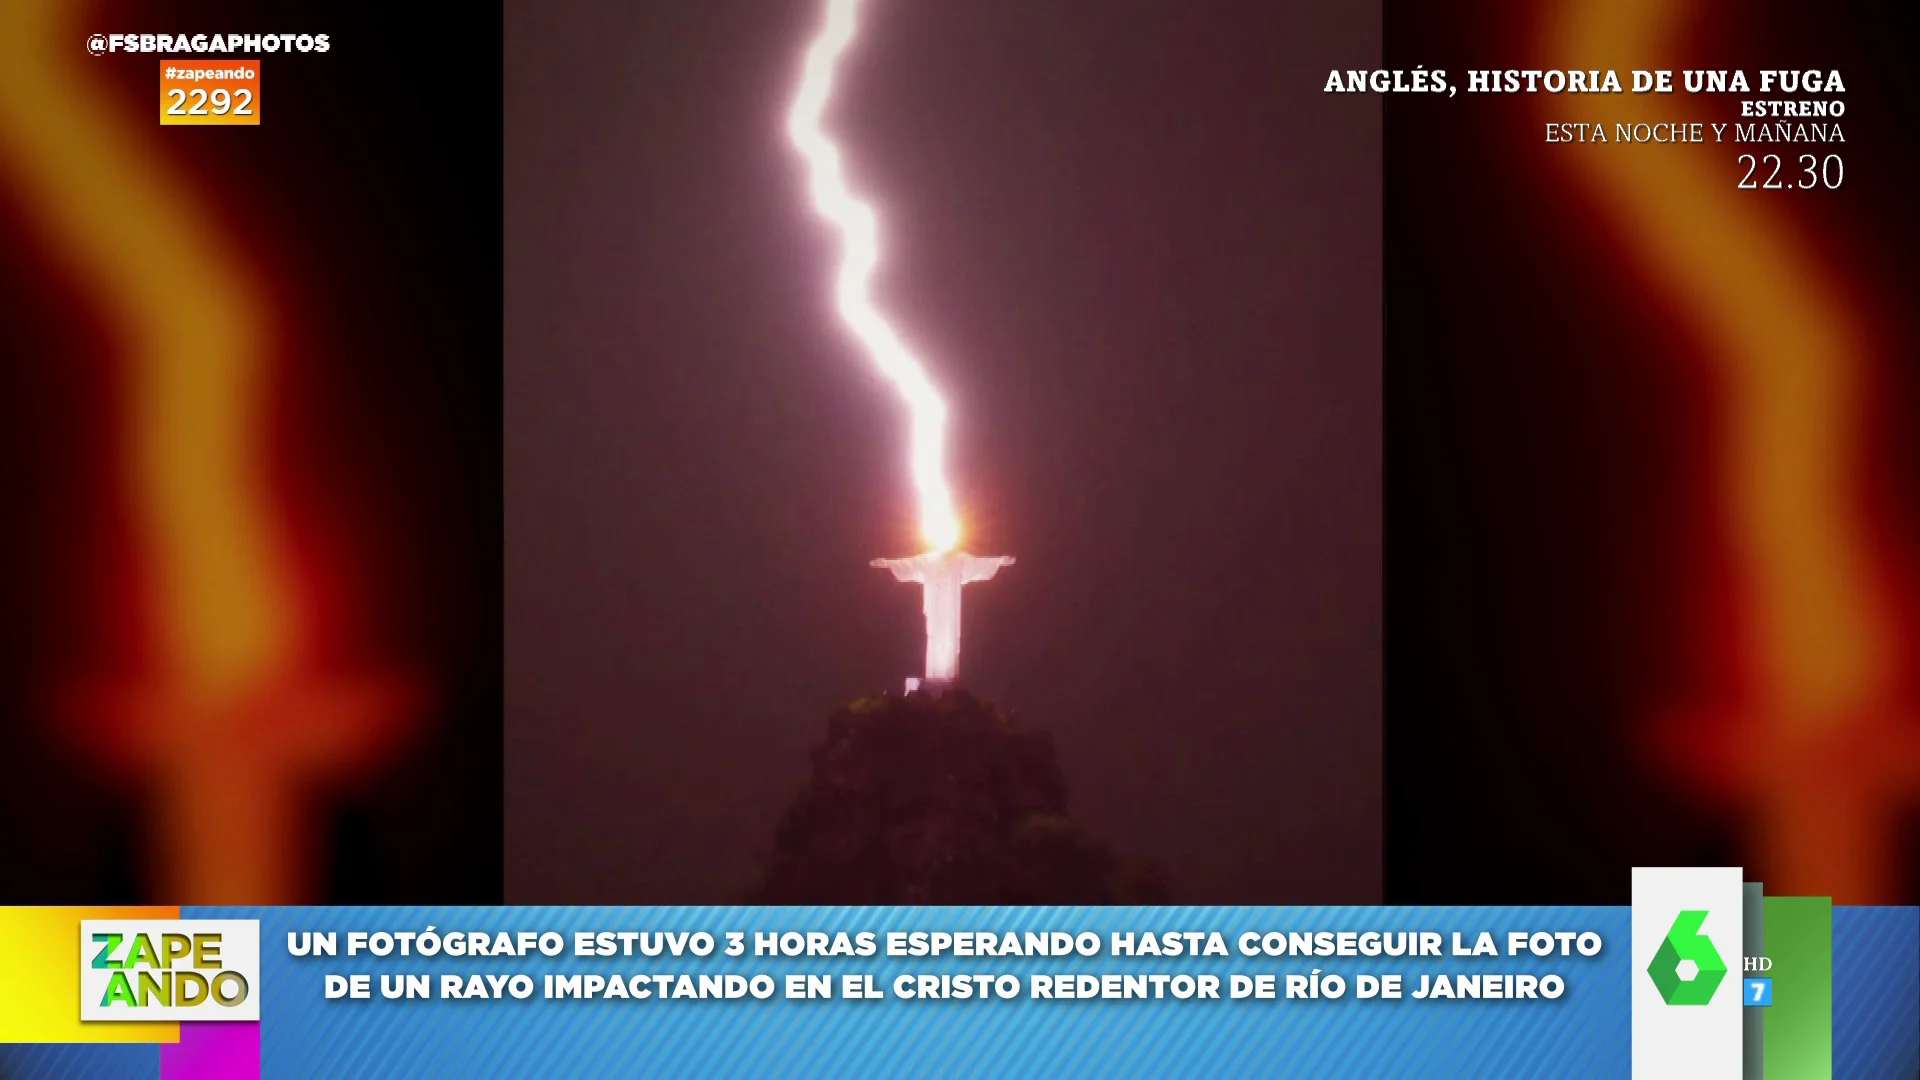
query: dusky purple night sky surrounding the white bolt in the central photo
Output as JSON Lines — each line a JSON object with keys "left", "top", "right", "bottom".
{"left": 505, "top": 0, "right": 1382, "bottom": 903}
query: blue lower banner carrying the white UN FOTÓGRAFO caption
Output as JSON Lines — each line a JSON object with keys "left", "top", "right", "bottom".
{"left": 0, "top": 907, "right": 1920, "bottom": 1080}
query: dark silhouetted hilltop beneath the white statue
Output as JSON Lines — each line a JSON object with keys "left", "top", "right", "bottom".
{"left": 753, "top": 690, "right": 1167, "bottom": 903}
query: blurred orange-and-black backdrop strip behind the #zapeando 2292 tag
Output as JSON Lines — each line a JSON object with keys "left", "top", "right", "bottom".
{"left": 0, "top": 0, "right": 499, "bottom": 903}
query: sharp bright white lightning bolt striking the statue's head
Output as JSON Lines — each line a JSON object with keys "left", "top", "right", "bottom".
{"left": 787, "top": 0, "right": 960, "bottom": 552}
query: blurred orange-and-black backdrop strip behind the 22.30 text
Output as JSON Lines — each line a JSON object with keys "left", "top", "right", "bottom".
{"left": 1388, "top": 0, "right": 1920, "bottom": 903}
